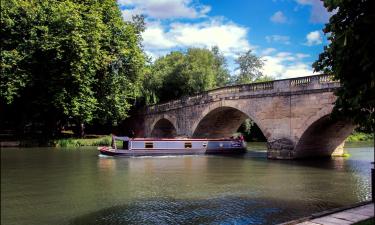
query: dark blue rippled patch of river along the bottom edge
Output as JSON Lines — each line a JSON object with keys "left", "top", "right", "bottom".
{"left": 69, "top": 196, "right": 328, "bottom": 225}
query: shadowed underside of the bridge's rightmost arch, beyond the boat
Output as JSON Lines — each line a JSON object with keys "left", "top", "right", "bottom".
{"left": 295, "top": 114, "right": 355, "bottom": 158}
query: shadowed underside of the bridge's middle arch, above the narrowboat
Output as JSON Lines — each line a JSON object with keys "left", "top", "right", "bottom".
{"left": 192, "top": 106, "right": 264, "bottom": 138}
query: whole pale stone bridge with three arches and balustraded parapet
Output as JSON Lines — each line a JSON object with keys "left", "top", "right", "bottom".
{"left": 139, "top": 75, "right": 354, "bottom": 159}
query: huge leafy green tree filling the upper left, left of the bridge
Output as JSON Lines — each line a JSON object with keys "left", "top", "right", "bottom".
{"left": 0, "top": 0, "right": 144, "bottom": 134}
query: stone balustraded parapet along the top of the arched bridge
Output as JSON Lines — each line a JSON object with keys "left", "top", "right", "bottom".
{"left": 146, "top": 74, "right": 340, "bottom": 114}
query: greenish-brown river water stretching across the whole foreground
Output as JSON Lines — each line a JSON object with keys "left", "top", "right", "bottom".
{"left": 1, "top": 143, "right": 374, "bottom": 225}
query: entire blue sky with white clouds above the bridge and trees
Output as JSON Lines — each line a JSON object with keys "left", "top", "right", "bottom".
{"left": 118, "top": 0, "right": 329, "bottom": 79}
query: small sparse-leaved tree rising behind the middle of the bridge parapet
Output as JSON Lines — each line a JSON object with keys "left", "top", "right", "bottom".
{"left": 234, "top": 50, "right": 264, "bottom": 84}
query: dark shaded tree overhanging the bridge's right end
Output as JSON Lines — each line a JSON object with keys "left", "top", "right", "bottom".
{"left": 313, "top": 0, "right": 375, "bottom": 132}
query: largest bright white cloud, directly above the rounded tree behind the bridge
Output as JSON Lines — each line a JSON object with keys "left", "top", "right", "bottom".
{"left": 143, "top": 19, "right": 252, "bottom": 57}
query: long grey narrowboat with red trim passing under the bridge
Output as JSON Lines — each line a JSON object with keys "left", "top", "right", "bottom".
{"left": 98, "top": 136, "right": 246, "bottom": 156}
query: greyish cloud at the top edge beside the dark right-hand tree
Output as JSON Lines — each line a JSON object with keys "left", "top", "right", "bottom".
{"left": 296, "top": 0, "right": 330, "bottom": 23}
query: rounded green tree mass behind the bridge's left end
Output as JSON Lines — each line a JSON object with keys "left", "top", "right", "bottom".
{"left": 143, "top": 47, "right": 229, "bottom": 104}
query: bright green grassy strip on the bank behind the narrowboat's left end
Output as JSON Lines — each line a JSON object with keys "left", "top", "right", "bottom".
{"left": 53, "top": 135, "right": 112, "bottom": 147}
